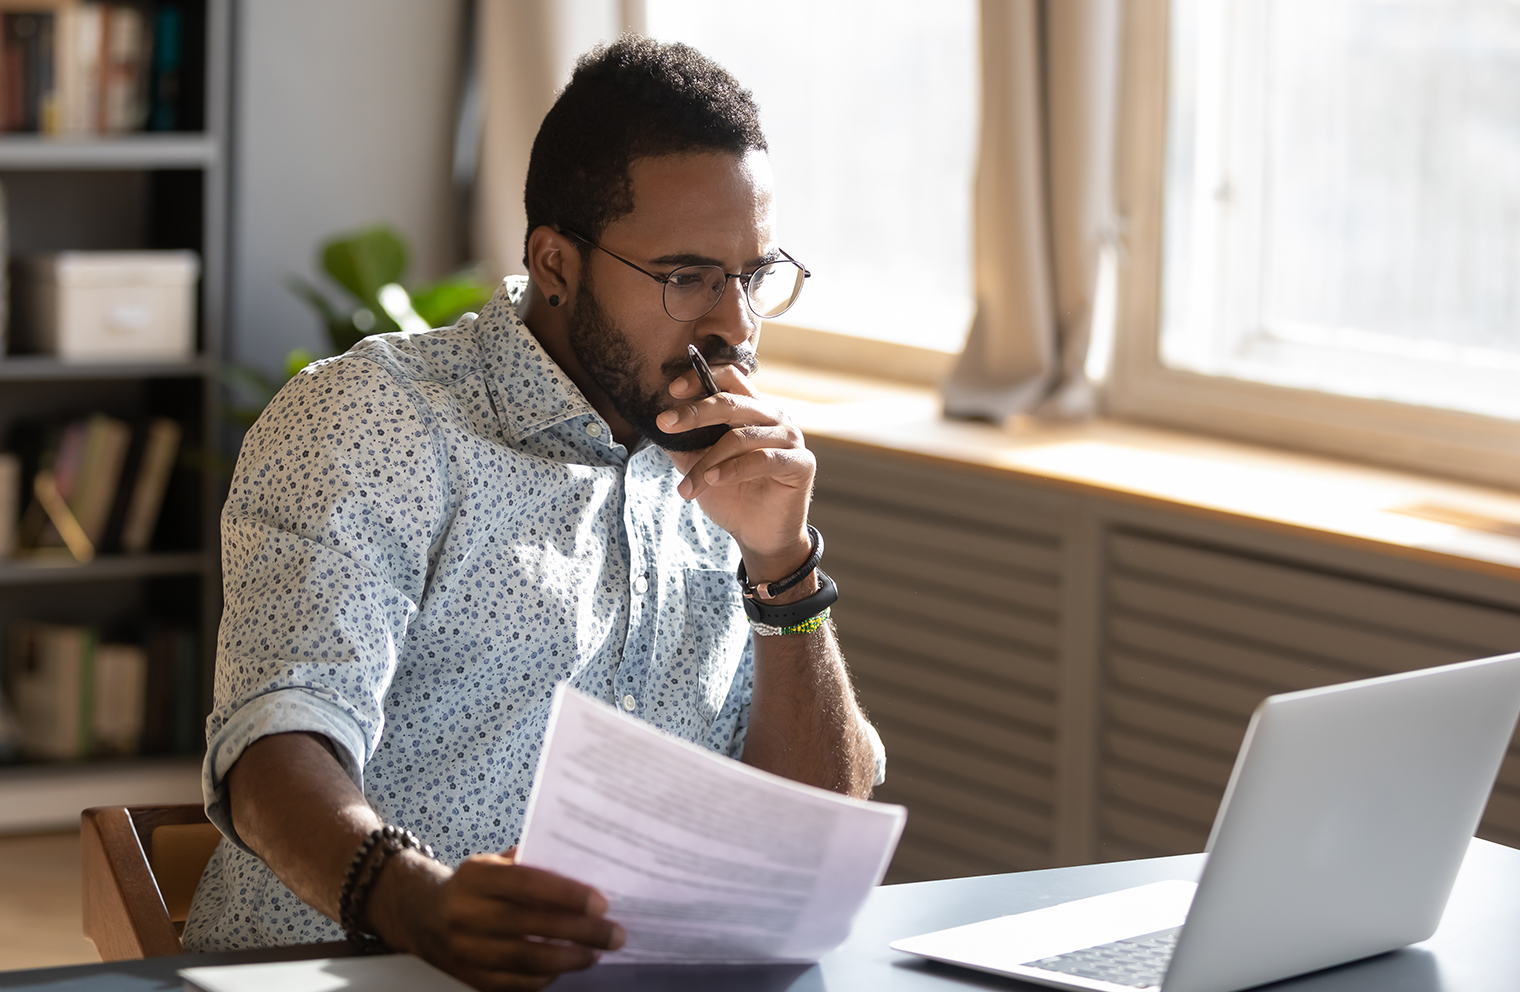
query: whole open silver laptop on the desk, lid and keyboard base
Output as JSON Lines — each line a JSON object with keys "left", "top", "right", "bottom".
{"left": 892, "top": 653, "right": 1520, "bottom": 992}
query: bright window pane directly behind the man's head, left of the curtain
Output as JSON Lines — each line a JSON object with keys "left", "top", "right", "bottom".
{"left": 648, "top": 0, "right": 979, "bottom": 351}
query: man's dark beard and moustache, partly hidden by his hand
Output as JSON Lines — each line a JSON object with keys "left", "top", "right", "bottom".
{"left": 567, "top": 269, "right": 758, "bottom": 451}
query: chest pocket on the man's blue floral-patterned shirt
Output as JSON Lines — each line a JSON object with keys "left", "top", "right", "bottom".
{"left": 669, "top": 568, "right": 749, "bottom": 725}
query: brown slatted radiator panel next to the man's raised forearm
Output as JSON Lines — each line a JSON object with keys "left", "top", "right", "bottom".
{"left": 812, "top": 444, "right": 1061, "bottom": 881}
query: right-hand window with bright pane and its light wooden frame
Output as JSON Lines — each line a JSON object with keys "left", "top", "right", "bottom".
{"left": 1111, "top": 0, "right": 1520, "bottom": 483}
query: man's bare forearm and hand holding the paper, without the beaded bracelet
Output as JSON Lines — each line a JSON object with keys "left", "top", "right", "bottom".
{"left": 226, "top": 734, "right": 625, "bottom": 990}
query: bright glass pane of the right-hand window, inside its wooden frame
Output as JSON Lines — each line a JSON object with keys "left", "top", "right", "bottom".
{"left": 1163, "top": 0, "right": 1520, "bottom": 418}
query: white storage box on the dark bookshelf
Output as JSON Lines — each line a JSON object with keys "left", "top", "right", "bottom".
{"left": 12, "top": 251, "right": 201, "bottom": 362}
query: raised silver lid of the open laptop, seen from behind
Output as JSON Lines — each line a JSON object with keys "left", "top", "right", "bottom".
{"left": 1163, "top": 653, "right": 1520, "bottom": 992}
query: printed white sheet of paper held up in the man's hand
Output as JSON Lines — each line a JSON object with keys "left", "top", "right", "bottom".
{"left": 518, "top": 685, "right": 907, "bottom": 963}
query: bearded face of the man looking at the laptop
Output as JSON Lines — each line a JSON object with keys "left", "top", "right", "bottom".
{"left": 567, "top": 152, "right": 775, "bottom": 451}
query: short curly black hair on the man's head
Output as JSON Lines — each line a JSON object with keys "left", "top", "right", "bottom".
{"left": 523, "top": 35, "right": 766, "bottom": 263}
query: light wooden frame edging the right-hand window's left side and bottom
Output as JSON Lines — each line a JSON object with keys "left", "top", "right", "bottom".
{"left": 1104, "top": 0, "right": 1520, "bottom": 486}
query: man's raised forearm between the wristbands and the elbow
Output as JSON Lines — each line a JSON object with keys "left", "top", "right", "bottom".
{"left": 743, "top": 610, "right": 876, "bottom": 799}
